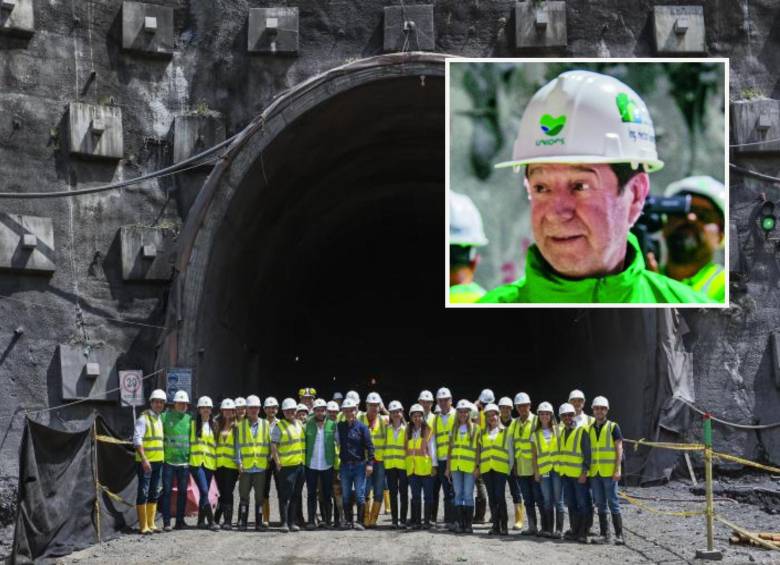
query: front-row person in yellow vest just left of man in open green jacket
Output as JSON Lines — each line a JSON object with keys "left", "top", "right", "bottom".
{"left": 271, "top": 398, "right": 306, "bottom": 532}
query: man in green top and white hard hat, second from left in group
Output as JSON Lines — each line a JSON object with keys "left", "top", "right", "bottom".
{"left": 160, "top": 390, "right": 192, "bottom": 532}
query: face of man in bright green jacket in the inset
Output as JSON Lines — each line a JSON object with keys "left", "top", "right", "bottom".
{"left": 525, "top": 164, "right": 650, "bottom": 278}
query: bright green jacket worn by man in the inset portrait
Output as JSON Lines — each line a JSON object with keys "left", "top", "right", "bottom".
{"left": 479, "top": 233, "right": 712, "bottom": 304}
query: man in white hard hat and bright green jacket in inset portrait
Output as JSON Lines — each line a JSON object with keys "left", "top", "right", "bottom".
{"left": 480, "top": 70, "right": 710, "bottom": 304}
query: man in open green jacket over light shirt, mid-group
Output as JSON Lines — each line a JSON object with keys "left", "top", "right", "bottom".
{"left": 305, "top": 398, "right": 336, "bottom": 530}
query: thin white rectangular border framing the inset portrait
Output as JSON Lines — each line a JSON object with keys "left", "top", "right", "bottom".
{"left": 444, "top": 57, "right": 731, "bottom": 309}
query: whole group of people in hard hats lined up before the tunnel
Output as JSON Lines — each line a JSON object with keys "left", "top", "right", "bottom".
{"left": 133, "top": 387, "right": 623, "bottom": 544}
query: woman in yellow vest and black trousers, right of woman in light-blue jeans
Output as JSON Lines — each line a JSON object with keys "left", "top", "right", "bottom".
{"left": 479, "top": 404, "right": 514, "bottom": 536}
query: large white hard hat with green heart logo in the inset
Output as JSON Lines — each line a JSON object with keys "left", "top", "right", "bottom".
{"left": 496, "top": 70, "right": 664, "bottom": 172}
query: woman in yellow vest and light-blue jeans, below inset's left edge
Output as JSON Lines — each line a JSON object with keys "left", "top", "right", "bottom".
{"left": 448, "top": 399, "right": 480, "bottom": 534}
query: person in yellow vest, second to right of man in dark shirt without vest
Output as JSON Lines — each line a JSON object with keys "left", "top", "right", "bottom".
{"left": 384, "top": 400, "right": 409, "bottom": 529}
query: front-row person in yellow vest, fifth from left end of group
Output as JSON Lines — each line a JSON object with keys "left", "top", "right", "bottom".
{"left": 234, "top": 394, "right": 271, "bottom": 531}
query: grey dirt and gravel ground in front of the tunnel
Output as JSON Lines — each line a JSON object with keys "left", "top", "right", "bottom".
{"left": 58, "top": 478, "right": 780, "bottom": 565}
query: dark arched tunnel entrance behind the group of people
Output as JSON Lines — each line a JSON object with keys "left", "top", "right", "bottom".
{"left": 164, "top": 54, "right": 676, "bottom": 446}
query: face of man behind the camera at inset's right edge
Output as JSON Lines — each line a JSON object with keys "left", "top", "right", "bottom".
{"left": 663, "top": 194, "right": 723, "bottom": 265}
